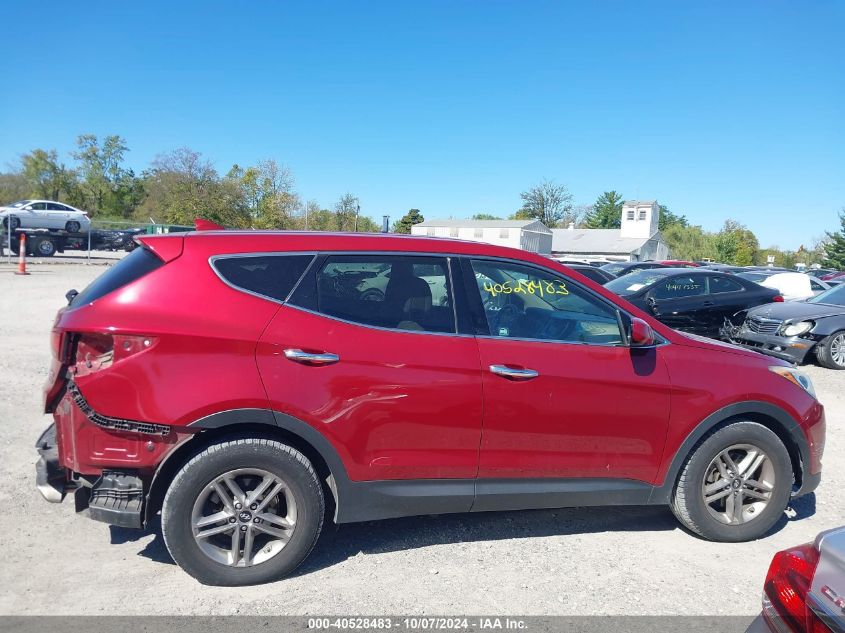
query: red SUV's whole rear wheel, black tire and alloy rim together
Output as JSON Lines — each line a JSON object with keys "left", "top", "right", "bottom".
{"left": 161, "top": 438, "right": 325, "bottom": 586}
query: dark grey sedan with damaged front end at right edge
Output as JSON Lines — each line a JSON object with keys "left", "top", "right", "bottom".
{"left": 729, "top": 286, "right": 845, "bottom": 369}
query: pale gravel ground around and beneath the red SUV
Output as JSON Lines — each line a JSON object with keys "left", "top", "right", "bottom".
{"left": 0, "top": 264, "right": 845, "bottom": 615}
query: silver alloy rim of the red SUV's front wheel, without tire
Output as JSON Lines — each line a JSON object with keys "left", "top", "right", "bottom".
{"left": 701, "top": 444, "right": 776, "bottom": 525}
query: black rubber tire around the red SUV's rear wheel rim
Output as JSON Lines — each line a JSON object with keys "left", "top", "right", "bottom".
{"left": 161, "top": 438, "right": 325, "bottom": 587}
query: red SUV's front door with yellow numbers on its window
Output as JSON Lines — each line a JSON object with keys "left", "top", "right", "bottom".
{"left": 464, "top": 259, "right": 670, "bottom": 482}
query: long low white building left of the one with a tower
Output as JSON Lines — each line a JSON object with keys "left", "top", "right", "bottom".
{"left": 411, "top": 220, "right": 552, "bottom": 255}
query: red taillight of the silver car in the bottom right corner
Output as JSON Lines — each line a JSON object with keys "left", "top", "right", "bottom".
{"left": 763, "top": 543, "right": 829, "bottom": 633}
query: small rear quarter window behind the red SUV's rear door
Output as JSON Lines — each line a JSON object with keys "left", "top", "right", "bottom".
{"left": 212, "top": 255, "right": 314, "bottom": 301}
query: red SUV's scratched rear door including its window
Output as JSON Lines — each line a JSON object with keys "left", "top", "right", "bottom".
{"left": 257, "top": 254, "right": 481, "bottom": 481}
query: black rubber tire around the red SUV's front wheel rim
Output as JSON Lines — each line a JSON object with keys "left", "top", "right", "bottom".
{"left": 671, "top": 421, "right": 794, "bottom": 543}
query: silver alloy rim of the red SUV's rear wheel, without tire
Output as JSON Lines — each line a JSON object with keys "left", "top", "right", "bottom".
{"left": 191, "top": 468, "right": 296, "bottom": 567}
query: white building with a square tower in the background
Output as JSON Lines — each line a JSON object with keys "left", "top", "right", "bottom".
{"left": 552, "top": 200, "right": 669, "bottom": 261}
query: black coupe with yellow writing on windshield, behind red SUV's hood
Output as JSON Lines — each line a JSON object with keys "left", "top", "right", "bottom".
{"left": 605, "top": 268, "right": 783, "bottom": 338}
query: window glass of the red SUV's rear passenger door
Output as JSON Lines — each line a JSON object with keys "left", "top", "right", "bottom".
{"left": 291, "top": 255, "right": 455, "bottom": 333}
